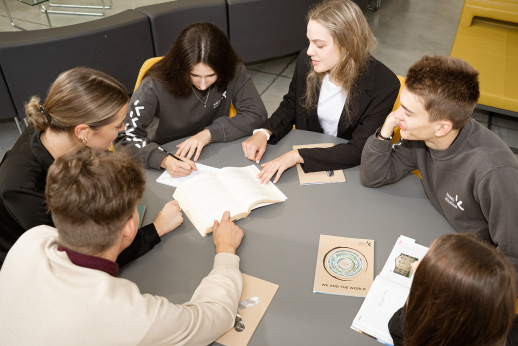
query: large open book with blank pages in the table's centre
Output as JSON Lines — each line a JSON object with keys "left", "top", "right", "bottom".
{"left": 173, "top": 165, "right": 287, "bottom": 236}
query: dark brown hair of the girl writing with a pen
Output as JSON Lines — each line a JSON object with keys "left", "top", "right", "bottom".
{"left": 144, "top": 23, "right": 241, "bottom": 98}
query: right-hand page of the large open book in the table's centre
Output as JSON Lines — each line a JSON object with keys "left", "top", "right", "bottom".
{"left": 217, "top": 165, "right": 287, "bottom": 208}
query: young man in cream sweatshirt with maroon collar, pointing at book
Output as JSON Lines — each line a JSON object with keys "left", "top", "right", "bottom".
{"left": 0, "top": 147, "right": 244, "bottom": 346}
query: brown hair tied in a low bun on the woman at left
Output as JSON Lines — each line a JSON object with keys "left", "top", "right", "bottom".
{"left": 25, "top": 67, "right": 129, "bottom": 137}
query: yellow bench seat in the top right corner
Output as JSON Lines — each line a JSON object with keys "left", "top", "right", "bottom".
{"left": 450, "top": 0, "right": 518, "bottom": 115}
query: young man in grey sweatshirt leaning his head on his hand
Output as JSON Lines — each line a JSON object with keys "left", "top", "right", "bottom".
{"left": 361, "top": 56, "right": 518, "bottom": 271}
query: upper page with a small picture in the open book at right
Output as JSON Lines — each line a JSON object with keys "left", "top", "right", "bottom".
{"left": 380, "top": 236, "right": 428, "bottom": 289}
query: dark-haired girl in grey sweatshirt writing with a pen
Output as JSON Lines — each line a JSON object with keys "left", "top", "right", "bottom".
{"left": 118, "top": 23, "right": 267, "bottom": 177}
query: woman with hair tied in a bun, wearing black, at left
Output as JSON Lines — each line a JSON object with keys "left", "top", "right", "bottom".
{"left": 0, "top": 68, "right": 185, "bottom": 266}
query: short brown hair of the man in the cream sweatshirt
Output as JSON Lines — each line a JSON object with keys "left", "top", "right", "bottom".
{"left": 45, "top": 146, "right": 146, "bottom": 255}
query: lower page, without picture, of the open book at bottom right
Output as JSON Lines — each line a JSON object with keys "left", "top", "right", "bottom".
{"left": 352, "top": 275, "right": 410, "bottom": 344}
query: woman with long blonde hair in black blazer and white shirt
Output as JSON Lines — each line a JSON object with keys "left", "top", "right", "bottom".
{"left": 243, "top": 0, "right": 400, "bottom": 184}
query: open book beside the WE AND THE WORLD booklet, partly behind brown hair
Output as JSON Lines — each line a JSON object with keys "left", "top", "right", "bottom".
{"left": 351, "top": 236, "right": 428, "bottom": 345}
